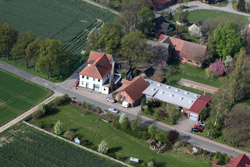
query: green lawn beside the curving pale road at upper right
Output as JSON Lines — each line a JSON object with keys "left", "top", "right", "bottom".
{"left": 188, "top": 10, "right": 249, "bottom": 25}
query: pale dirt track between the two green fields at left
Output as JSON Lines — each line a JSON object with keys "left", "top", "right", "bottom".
{"left": 0, "top": 92, "right": 62, "bottom": 133}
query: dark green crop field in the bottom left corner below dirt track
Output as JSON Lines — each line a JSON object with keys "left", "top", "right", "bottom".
{"left": 0, "top": 124, "right": 120, "bottom": 167}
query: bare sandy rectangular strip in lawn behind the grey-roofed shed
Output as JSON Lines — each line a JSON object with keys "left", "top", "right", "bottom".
{"left": 178, "top": 78, "right": 219, "bottom": 94}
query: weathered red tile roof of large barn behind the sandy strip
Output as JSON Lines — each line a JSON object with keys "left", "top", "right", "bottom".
{"left": 158, "top": 34, "right": 207, "bottom": 63}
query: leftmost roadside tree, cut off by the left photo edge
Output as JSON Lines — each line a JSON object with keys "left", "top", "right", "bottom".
{"left": 0, "top": 23, "right": 18, "bottom": 59}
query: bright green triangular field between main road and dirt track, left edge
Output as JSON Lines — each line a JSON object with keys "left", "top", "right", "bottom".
{"left": 0, "top": 69, "right": 52, "bottom": 126}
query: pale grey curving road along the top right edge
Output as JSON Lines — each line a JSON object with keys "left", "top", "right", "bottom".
{"left": 159, "top": 0, "right": 250, "bottom": 17}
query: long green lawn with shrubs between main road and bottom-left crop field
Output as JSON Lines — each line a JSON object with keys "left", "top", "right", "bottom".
{"left": 31, "top": 105, "right": 211, "bottom": 167}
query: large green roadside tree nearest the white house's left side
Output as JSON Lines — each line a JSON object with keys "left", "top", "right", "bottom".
{"left": 36, "top": 38, "right": 70, "bottom": 78}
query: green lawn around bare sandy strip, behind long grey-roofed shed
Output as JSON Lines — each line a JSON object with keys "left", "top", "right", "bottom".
{"left": 166, "top": 63, "right": 223, "bottom": 94}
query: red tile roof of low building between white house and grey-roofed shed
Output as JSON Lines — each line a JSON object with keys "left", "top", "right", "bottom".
{"left": 115, "top": 77, "right": 148, "bottom": 102}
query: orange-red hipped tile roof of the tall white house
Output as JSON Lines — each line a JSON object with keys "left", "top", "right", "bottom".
{"left": 80, "top": 51, "right": 112, "bottom": 79}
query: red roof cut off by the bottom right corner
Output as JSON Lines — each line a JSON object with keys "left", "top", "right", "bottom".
{"left": 225, "top": 154, "right": 250, "bottom": 167}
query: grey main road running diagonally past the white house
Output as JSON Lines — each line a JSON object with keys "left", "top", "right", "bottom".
{"left": 0, "top": 61, "right": 250, "bottom": 157}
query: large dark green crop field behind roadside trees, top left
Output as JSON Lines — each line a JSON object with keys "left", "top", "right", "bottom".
{"left": 0, "top": 0, "right": 114, "bottom": 80}
